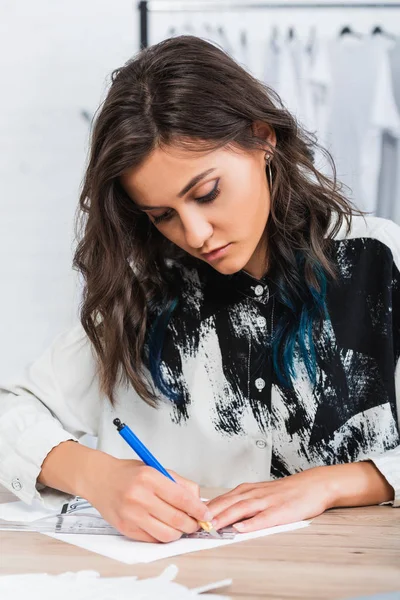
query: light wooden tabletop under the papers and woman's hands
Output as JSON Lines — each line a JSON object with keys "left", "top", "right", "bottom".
{"left": 0, "top": 488, "right": 400, "bottom": 600}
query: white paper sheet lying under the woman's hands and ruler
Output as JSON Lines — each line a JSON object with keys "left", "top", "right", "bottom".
{"left": 0, "top": 502, "right": 310, "bottom": 564}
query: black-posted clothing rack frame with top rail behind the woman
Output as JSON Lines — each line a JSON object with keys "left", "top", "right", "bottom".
{"left": 138, "top": 0, "right": 400, "bottom": 48}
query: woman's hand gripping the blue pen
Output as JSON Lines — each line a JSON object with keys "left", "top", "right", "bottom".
{"left": 80, "top": 451, "right": 212, "bottom": 542}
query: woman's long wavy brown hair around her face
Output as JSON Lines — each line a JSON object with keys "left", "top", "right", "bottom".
{"left": 73, "top": 36, "right": 353, "bottom": 405}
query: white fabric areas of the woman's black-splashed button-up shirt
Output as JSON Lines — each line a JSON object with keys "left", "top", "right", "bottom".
{"left": 0, "top": 217, "right": 400, "bottom": 506}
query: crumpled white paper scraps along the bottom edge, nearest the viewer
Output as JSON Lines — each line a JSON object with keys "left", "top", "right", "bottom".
{"left": 0, "top": 565, "right": 232, "bottom": 600}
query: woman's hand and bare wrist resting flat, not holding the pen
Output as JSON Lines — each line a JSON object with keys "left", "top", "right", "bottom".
{"left": 208, "top": 460, "right": 395, "bottom": 533}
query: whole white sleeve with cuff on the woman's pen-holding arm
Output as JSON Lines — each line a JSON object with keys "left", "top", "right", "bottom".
{"left": 0, "top": 324, "right": 102, "bottom": 507}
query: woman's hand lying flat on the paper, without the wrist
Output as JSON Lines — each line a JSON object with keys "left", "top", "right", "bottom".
{"left": 208, "top": 467, "right": 331, "bottom": 533}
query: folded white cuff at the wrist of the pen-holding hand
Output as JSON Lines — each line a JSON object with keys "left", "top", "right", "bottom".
{"left": 0, "top": 419, "right": 78, "bottom": 509}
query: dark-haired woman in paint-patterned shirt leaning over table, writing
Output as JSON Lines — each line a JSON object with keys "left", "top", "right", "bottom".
{"left": 0, "top": 36, "right": 400, "bottom": 541}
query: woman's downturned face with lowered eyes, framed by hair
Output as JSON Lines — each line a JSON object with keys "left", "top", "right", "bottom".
{"left": 121, "top": 130, "right": 276, "bottom": 277}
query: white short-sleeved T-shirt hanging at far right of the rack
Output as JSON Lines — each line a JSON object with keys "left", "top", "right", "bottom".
{"left": 313, "top": 37, "right": 400, "bottom": 212}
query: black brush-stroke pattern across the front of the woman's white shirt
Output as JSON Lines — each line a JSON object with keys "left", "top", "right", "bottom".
{"left": 152, "top": 230, "right": 400, "bottom": 477}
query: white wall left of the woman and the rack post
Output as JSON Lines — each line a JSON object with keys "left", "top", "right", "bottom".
{"left": 0, "top": 0, "right": 139, "bottom": 380}
